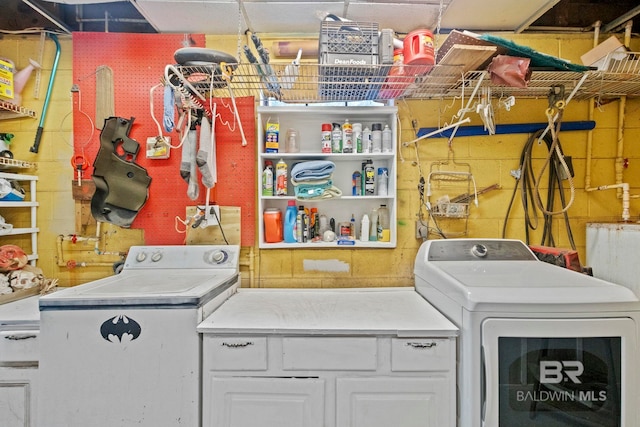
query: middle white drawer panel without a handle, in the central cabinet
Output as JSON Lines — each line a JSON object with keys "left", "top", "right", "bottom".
{"left": 282, "top": 337, "right": 378, "bottom": 371}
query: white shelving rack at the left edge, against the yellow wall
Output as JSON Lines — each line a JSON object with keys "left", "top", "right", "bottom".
{"left": 0, "top": 172, "right": 40, "bottom": 266}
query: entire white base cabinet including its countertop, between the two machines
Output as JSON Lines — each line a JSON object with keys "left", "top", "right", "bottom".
{"left": 198, "top": 288, "right": 457, "bottom": 427}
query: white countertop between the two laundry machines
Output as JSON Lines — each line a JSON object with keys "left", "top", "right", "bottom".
{"left": 198, "top": 288, "right": 458, "bottom": 337}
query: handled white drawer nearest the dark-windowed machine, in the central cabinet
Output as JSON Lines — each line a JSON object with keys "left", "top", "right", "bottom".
{"left": 391, "top": 338, "right": 455, "bottom": 371}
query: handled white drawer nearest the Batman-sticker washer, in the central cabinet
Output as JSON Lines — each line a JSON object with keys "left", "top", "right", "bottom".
{"left": 203, "top": 334, "right": 267, "bottom": 371}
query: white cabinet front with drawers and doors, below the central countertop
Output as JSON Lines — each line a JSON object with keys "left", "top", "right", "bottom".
{"left": 203, "top": 334, "right": 456, "bottom": 427}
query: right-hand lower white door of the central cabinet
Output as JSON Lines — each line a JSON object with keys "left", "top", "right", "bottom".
{"left": 336, "top": 375, "right": 455, "bottom": 427}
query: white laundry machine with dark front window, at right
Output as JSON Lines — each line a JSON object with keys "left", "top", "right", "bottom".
{"left": 414, "top": 239, "right": 640, "bottom": 427}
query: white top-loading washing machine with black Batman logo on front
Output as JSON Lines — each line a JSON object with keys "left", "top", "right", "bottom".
{"left": 38, "top": 245, "right": 240, "bottom": 427}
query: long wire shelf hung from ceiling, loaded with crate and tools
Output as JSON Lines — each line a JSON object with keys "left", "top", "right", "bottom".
{"left": 169, "top": 53, "right": 640, "bottom": 103}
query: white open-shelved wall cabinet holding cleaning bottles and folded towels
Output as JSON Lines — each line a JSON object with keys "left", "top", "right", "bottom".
{"left": 257, "top": 105, "right": 398, "bottom": 249}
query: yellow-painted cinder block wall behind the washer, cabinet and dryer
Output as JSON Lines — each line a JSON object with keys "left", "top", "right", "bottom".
{"left": 0, "top": 34, "right": 640, "bottom": 288}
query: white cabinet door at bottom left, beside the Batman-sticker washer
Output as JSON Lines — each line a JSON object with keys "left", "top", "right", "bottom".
{"left": 0, "top": 367, "right": 37, "bottom": 427}
